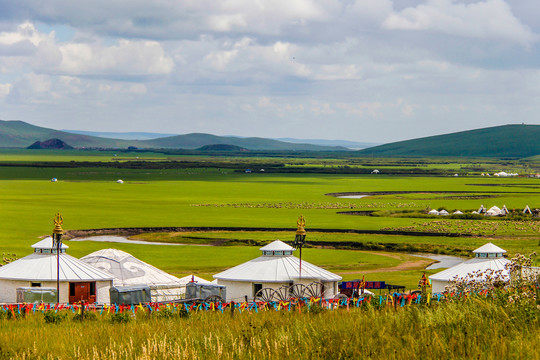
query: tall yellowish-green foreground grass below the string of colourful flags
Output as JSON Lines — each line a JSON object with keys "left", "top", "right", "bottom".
{"left": 0, "top": 300, "right": 540, "bottom": 359}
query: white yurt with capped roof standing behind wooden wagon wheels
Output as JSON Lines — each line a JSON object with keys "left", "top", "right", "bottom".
{"left": 214, "top": 240, "right": 341, "bottom": 301}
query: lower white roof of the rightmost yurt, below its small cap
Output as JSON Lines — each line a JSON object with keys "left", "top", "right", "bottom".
{"left": 429, "top": 257, "right": 510, "bottom": 281}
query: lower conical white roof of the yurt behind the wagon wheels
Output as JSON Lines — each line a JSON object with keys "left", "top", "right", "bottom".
{"left": 214, "top": 255, "right": 341, "bottom": 283}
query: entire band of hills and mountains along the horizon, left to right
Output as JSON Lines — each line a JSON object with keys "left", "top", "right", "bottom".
{"left": 0, "top": 120, "right": 540, "bottom": 158}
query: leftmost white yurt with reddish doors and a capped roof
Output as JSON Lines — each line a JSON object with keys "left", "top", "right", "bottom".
{"left": 0, "top": 237, "right": 113, "bottom": 303}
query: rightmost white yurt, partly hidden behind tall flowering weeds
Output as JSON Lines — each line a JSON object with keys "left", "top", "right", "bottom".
{"left": 429, "top": 243, "right": 510, "bottom": 293}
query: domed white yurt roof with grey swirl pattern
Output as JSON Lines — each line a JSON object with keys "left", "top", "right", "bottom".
{"left": 81, "top": 249, "right": 182, "bottom": 286}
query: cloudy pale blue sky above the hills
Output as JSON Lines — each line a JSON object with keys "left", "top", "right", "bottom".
{"left": 0, "top": 0, "right": 540, "bottom": 143}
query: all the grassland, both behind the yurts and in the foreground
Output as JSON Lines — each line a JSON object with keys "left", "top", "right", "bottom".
{"left": 0, "top": 150, "right": 540, "bottom": 359}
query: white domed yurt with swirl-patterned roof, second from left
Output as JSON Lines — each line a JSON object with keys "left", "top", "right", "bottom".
{"left": 81, "top": 249, "right": 188, "bottom": 302}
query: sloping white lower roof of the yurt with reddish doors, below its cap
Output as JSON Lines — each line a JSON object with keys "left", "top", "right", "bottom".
{"left": 0, "top": 253, "right": 113, "bottom": 281}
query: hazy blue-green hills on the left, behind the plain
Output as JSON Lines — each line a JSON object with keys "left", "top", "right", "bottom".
{"left": 0, "top": 120, "right": 349, "bottom": 151}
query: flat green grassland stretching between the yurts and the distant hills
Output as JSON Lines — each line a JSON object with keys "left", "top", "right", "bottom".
{"left": 0, "top": 150, "right": 540, "bottom": 287}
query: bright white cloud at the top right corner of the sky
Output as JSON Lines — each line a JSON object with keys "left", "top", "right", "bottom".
{"left": 383, "top": 0, "right": 538, "bottom": 46}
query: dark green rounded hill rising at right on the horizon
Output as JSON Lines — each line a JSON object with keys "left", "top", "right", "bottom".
{"left": 357, "top": 124, "right": 540, "bottom": 158}
